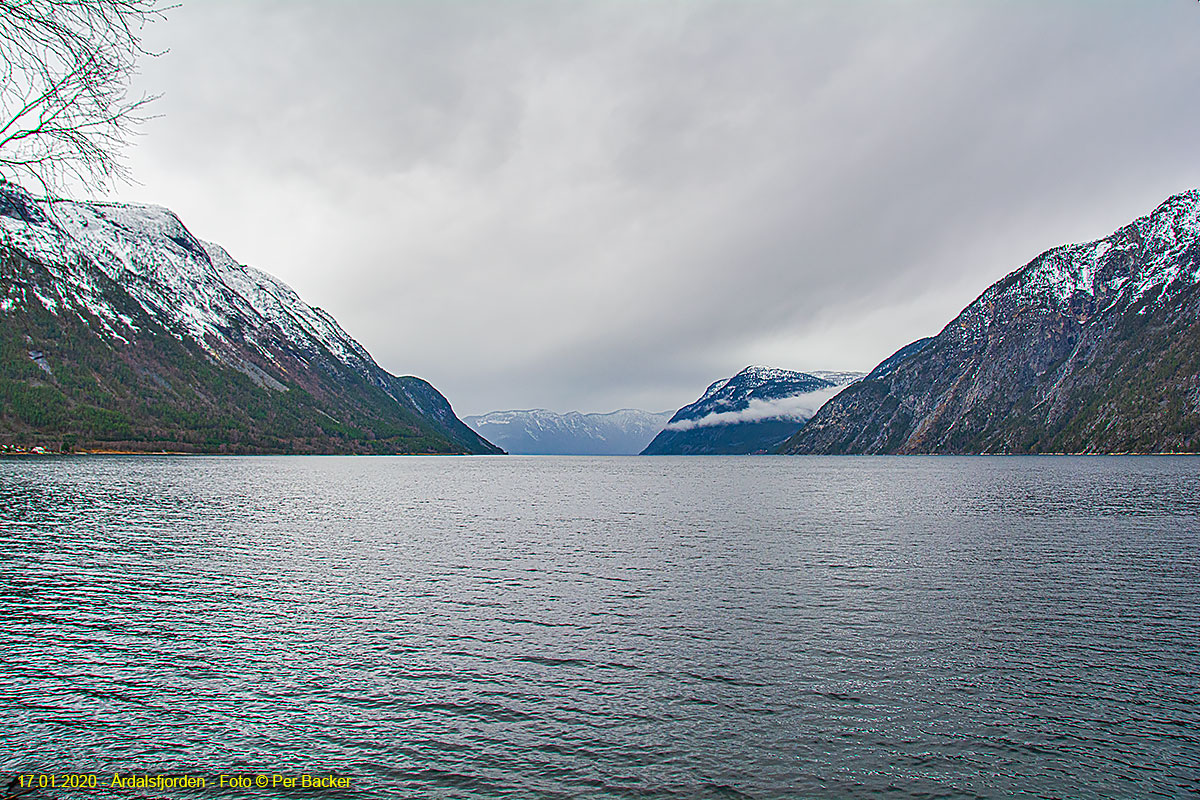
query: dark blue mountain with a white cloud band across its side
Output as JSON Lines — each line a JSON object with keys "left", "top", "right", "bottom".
{"left": 642, "top": 367, "right": 862, "bottom": 456}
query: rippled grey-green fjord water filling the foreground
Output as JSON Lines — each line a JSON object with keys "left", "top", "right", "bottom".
{"left": 0, "top": 457, "right": 1200, "bottom": 798}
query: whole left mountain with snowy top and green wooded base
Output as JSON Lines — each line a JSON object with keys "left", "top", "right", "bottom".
{"left": 0, "top": 184, "right": 498, "bottom": 453}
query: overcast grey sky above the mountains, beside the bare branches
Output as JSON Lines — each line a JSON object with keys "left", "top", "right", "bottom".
{"left": 105, "top": 0, "right": 1200, "bottom": 415}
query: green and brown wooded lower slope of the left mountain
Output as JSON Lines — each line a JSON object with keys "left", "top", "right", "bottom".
{"left": 0, "top": 247, "right": 477, "bottom": 453}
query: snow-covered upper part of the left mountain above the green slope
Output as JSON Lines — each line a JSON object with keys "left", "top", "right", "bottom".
{"left": 0, "top": 184, "right": 377, "bottom": 373}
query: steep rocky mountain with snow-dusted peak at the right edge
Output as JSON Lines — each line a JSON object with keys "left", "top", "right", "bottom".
{"left": 781, "top": 184, "right": 1200, "bottom": 453}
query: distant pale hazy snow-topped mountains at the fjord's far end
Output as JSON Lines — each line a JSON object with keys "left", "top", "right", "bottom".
{"left": 463, "top": 408, "right": 671, "bottom": 456}
